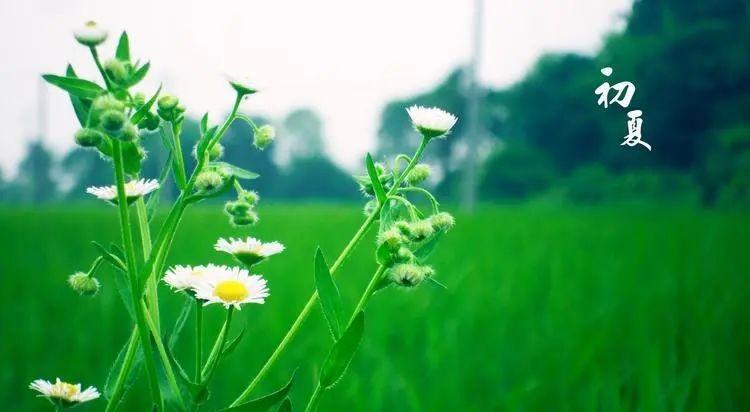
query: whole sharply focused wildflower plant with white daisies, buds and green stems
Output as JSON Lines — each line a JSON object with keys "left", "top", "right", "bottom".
{"left": 36, "top": 22, "right": 457, "bottom": 412}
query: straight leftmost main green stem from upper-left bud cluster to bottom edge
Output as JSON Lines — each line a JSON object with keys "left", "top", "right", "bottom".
{"left": 112, "top": 139, "right": 164, "bottom": 411}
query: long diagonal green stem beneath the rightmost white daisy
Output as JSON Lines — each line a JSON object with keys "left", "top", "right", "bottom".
{"left": 230, "top": 138, "right": 429, "bottom": 407}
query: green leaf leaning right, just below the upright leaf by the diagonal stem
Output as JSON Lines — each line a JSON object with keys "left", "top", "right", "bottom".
{"left": 320, "top": 311, "right": 365, "bottom": 389}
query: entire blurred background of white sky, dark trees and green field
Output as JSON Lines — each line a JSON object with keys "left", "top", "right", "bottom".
{"left": 0, "top": 0, "right": 750, "bottom": 411}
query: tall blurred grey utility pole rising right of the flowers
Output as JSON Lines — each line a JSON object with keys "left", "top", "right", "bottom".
{"left": 462, "top": 0, "right": 484, "bottom": 212}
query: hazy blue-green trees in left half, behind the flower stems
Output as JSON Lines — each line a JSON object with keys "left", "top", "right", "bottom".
{"left": 0, "top": 109, "right": 358, "bottom": 204}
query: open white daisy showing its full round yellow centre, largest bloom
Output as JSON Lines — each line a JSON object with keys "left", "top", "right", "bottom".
{"left": 193, "top": 266, "right": 269, "bottom": 309}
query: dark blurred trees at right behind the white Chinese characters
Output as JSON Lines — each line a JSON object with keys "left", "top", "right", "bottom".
{"left": 378, "top": 0, "right": 750, "bottom": 206}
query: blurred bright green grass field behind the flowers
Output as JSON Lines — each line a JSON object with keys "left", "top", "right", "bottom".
{"left": 0, "top": 205, "right": 750, "bottom": 412}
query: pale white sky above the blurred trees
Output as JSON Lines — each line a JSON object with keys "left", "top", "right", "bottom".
{"left": 0, "top": 0, "right": 631, "bottom": 174}
